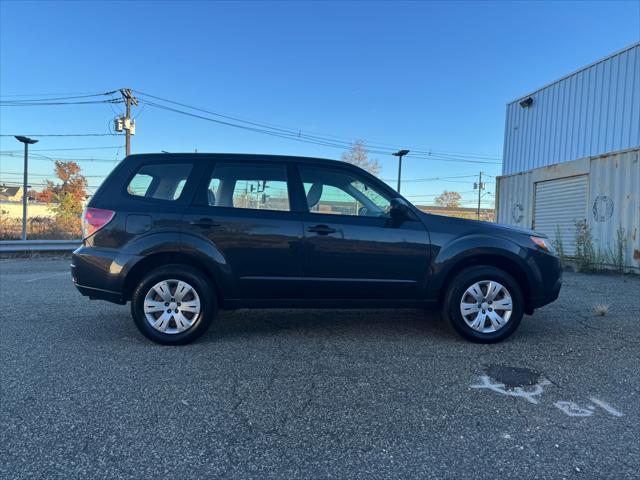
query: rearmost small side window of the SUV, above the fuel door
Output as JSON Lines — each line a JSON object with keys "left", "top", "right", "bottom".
{"left": 127, "top": 163, "right": 193, "bottom": 200}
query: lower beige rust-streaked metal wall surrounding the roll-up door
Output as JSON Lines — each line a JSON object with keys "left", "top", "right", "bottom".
{"left": 496, "top": 149, "right": 640, "bottom": 268}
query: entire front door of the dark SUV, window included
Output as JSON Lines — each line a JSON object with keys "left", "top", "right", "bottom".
{"left": 299, "top": 165, "right": 430, "bottom": 299}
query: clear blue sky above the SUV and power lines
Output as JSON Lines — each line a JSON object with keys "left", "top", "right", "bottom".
{"left": 0, "top": 1, "right": 640, "bottom": 203}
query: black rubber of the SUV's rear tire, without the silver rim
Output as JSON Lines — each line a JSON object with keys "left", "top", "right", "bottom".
{"left": 131, "top": 264, "right": 217, "bottom": 345}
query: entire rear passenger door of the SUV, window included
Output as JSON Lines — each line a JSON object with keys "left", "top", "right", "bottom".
{"left": 184, "top": 162, "right": 303, "bottom": 298}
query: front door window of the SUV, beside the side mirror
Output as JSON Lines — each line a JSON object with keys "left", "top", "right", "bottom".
{"left": 299, "top": 165, "right": 391, "bottom": 218}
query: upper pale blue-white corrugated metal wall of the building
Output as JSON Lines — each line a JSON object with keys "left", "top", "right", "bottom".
{"left": 502, "top": 43, "right": 640, "bottom": 175}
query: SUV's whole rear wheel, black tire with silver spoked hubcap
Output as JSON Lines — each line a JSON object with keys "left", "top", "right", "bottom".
{"left": 131, "top": 264, "right": 217, "bottom": 345}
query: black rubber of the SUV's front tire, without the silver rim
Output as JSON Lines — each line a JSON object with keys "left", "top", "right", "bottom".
{"left": 442, "top": 265, "right": 524, "bottom": 343}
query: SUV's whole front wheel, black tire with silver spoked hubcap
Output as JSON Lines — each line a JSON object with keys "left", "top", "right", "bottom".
{"left": 442, "top": 265, "right": 524, "bottom": 343}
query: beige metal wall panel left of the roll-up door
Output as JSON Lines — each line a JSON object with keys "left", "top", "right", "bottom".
{"left": 496, "top": 172, "right": 533, "bottom": 228}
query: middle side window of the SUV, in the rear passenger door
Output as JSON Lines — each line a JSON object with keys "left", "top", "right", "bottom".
{"left": 207, "top": 162, "right": 290, "bottom": 211}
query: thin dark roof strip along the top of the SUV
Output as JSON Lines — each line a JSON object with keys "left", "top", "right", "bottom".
{"left": 125, "top": 152, "right": 354, "bottom": 167}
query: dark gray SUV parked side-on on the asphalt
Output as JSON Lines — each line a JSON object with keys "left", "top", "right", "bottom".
{"left": 71, "top": 154, "right": 561, "bottom": 344}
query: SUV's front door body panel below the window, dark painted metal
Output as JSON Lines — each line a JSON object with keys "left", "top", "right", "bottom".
{"left": 303, "top": 214, "right": 429, "bottom": 298}
